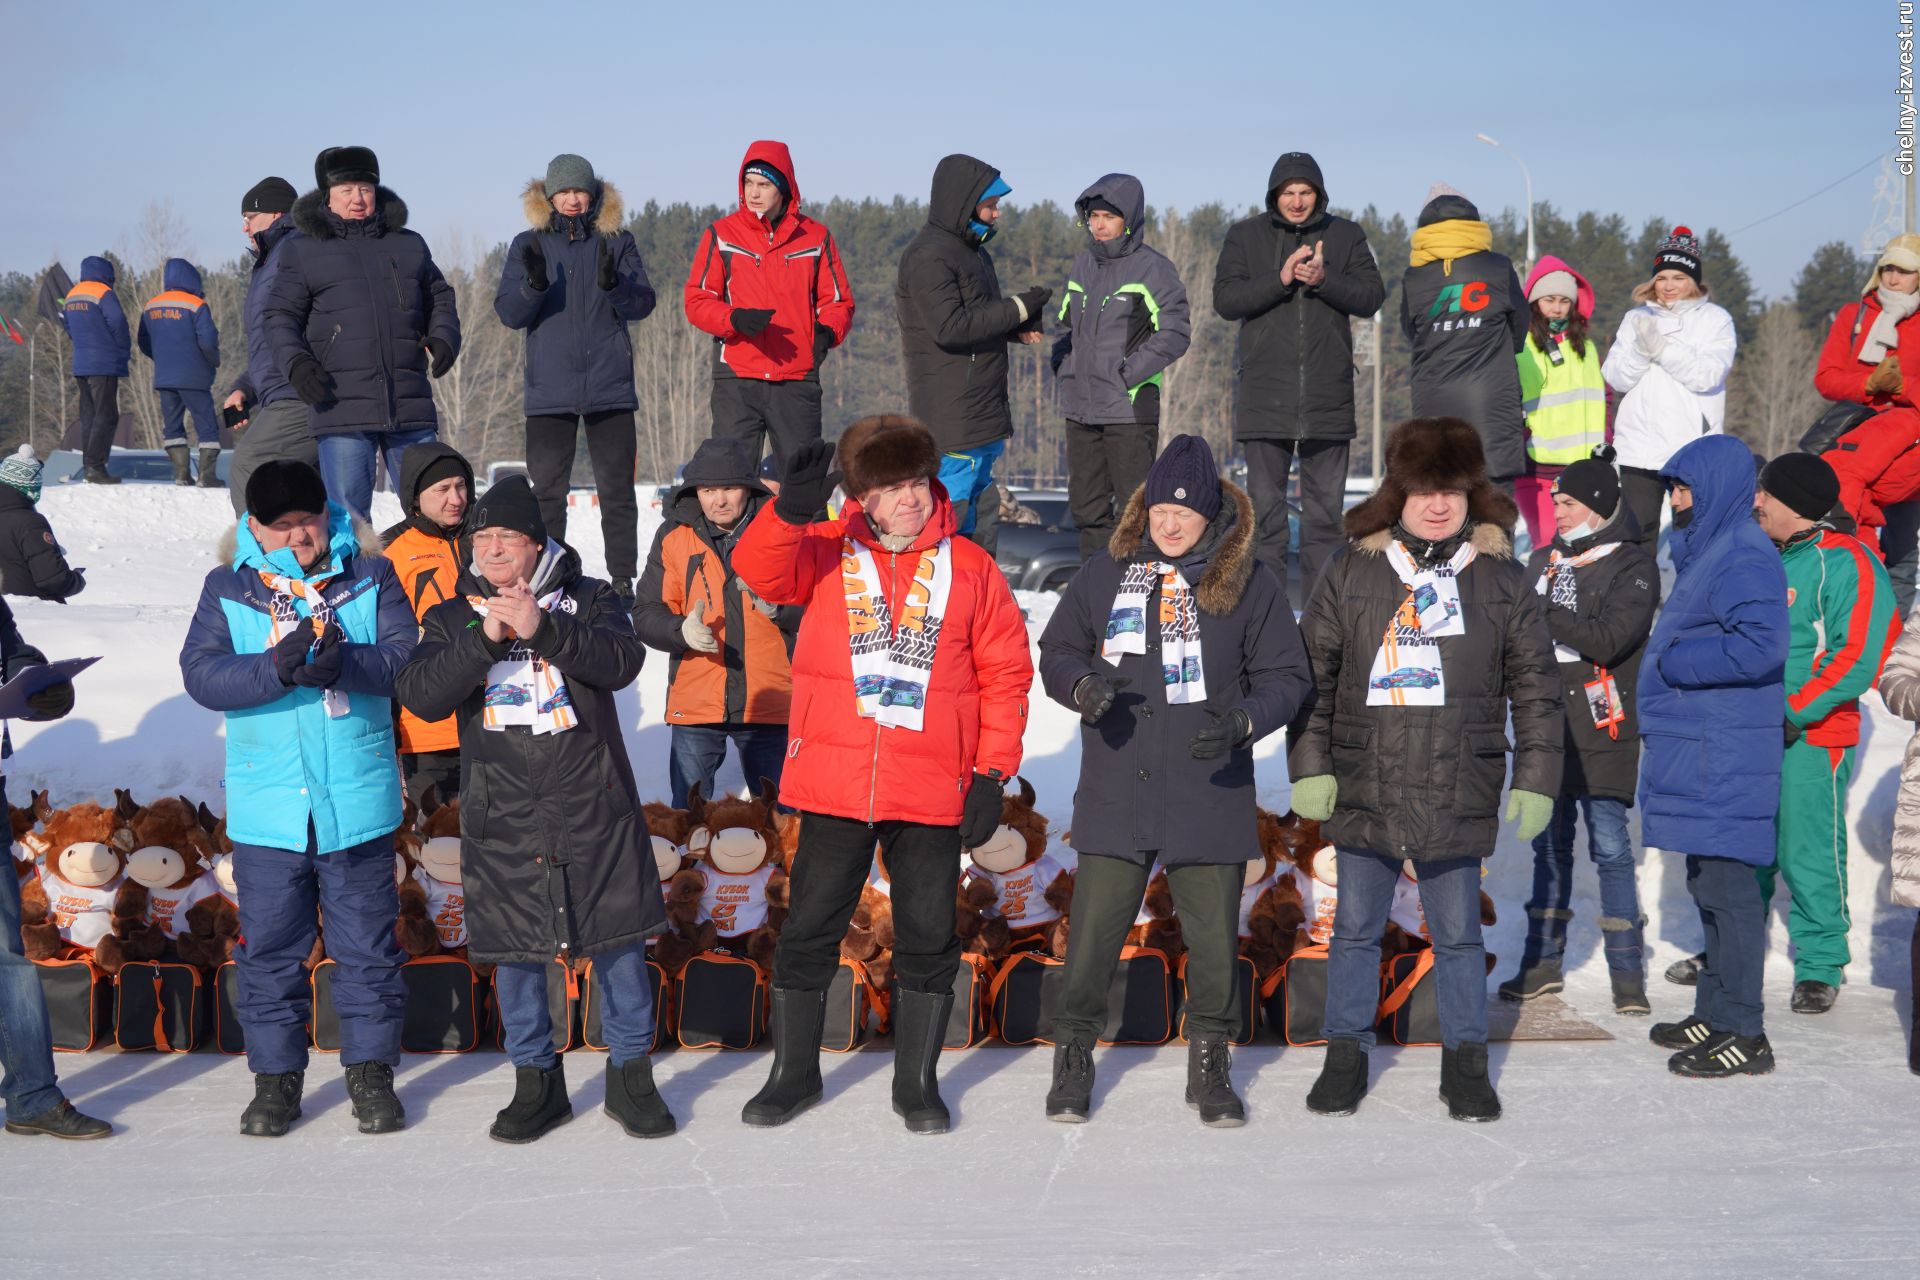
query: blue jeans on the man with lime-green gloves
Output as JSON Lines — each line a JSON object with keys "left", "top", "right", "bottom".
{"left": 1327, "top": 846, "right": 1489, "bottom": 1050}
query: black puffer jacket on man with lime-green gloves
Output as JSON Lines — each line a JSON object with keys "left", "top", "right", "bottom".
{"left": 1286, "top": 486, "right": 1563, "bottom": 862}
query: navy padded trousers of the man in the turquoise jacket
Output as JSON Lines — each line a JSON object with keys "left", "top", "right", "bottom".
{"left": 234, "top": 837, "right": 407, "bottom": 1075}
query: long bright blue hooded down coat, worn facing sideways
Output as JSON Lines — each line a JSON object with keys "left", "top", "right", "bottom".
{"left": 1628, "top": 435, "right": 1789, "bottom": 867}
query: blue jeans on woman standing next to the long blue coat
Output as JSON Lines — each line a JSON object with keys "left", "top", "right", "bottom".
{"left": 1521, "top": 796, "right": 1642, "bottom": 973}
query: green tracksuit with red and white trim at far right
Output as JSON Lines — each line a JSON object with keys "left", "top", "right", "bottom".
{"left": 1759, "top": 524, "right": 1901, "bottom": 986}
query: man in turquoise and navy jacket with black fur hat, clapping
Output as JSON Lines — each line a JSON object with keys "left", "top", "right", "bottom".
{"left": 180, "top": 461, "right": 419, "bottom": 1138}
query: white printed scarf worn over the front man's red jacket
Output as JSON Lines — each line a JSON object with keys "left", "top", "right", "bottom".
{"left": 841, "top": 537, "right": 954, "bottom": 733}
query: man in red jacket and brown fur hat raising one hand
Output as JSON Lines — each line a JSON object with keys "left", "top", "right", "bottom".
{"left": 733, "top": 415, "right": 1033, "bottom": 1134}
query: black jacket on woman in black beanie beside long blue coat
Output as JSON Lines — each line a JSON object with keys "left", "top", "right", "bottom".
{"left": 1526, "top": 501, "right": 1661, "bottom": 804}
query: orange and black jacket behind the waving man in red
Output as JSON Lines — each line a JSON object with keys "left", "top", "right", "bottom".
{"left": 634, "top": 484, "right": 803, "bottom": 725}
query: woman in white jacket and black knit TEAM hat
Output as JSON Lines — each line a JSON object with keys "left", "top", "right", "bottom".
{"left": 1601, "top": 226, "right": 1734, "bottom": 549}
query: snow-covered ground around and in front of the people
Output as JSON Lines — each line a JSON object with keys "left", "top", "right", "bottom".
{"left": 0, "top": 486, "right": 1920, "bottom": 1278}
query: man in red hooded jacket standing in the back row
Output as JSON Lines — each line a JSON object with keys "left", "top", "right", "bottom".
{"left": 687, "top": 142, "right": 852, "bottom": 479}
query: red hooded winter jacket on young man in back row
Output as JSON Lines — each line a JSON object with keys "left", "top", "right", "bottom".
{"left": 687, "top": 142, "right": 852, "bottom": 382}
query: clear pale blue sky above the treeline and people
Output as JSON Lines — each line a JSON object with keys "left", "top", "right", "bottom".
{"left": 0, "top": 0, "right": 1897, "bottom": 294}
